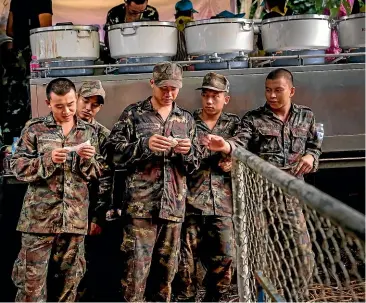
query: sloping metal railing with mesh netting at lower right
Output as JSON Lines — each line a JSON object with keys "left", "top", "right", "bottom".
{"left": 232, "top": 148, "right": 365, "bottom": 302}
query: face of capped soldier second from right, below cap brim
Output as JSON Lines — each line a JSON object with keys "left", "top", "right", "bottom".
{"left": 201, "top": 89, "right": 230, "bottom": 116}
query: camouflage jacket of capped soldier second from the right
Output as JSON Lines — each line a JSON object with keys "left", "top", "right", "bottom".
{"left": 186, "top": 110, "right": 240, "bottom": 216}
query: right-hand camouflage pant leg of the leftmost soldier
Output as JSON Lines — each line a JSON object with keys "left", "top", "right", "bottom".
{"left": 48, "top": 234, "right": 86, "bottom": 302}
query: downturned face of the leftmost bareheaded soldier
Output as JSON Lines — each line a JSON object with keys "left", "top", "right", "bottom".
{"left": 46, "top": 90, "right": 76, "bottom": 123}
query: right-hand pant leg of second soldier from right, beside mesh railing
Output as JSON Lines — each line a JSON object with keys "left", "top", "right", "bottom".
{"left": 200, "top": 216, "right": 235, "bottom": 302}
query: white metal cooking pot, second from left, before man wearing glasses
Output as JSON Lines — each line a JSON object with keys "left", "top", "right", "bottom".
{"left": 108, "top": 21, "right": 178, "bottom": 59}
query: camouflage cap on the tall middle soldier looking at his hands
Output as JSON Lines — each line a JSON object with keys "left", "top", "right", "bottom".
{"left": 153, "top": 62, "right": 183, "bottom": 88}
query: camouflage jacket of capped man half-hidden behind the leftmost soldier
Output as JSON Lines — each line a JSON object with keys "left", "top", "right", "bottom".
{"left": 89, "top": 119, "right": 113, "bottom": 225}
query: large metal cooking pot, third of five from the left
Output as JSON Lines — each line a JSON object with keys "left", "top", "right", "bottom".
{"left": 184, "top": 18, "right": 254, "bottom": 55}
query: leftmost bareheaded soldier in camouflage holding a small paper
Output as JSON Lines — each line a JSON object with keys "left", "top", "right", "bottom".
{"left": 11, "top": 78, "right": 105, "bottom": 302}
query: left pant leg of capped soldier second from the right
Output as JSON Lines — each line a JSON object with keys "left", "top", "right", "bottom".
{"left": 173, "top": 216, "right": 202, "bottom": 302}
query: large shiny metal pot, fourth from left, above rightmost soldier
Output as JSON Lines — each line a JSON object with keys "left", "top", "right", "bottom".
{"left": 261, "top": 15, "right": 332, "bottom": 52}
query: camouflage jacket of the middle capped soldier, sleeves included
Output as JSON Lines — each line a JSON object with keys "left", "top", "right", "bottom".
{"left": 108, "top": 98, "right": 201, "bottom": 222}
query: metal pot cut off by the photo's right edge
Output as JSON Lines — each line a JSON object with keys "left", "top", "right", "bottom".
{"left": 338, "top": 13, "right": 365, "bottom": 49}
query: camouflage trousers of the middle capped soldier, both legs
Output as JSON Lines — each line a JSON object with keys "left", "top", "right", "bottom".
{"left": 121, "top": 219, "right": 182, "bottom": 302}
